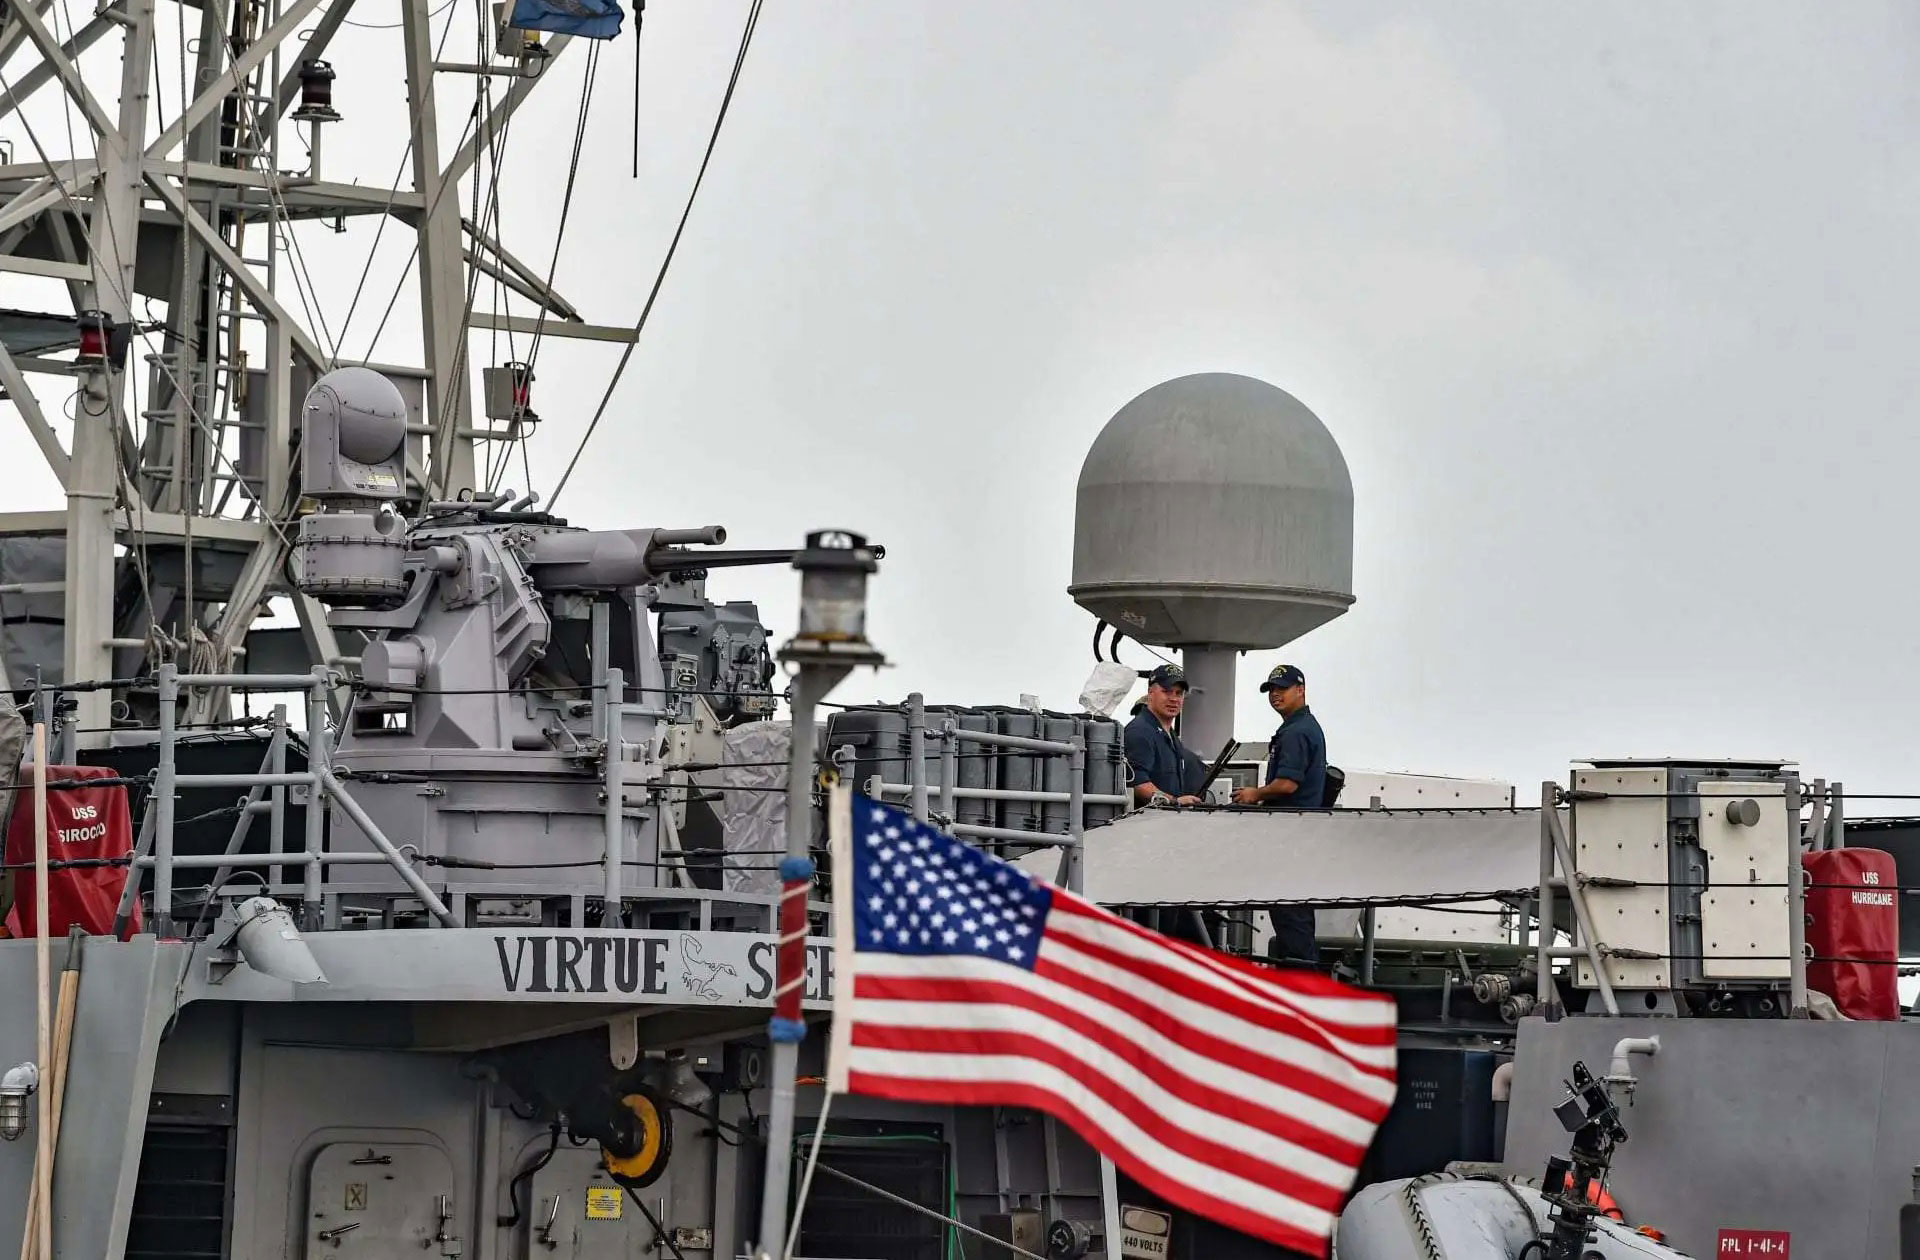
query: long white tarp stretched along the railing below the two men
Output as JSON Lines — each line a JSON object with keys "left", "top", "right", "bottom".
{"left": 1021, "top": 809, "right": 1540, "bottom": 905}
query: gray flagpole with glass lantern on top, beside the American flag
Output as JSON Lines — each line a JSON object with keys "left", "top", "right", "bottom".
{"left": 753, "top": 530, "right": 883, "bottom": 1260}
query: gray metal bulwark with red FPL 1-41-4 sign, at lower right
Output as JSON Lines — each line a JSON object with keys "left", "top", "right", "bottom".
{"left": 1505, "top": 1016, "right": 1920, "bottom": 1260}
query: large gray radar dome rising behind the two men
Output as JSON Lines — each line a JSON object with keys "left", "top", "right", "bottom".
{"left": 1068, "top": 373, "right": 1354, "bottom": 649}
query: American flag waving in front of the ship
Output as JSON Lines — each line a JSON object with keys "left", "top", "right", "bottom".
{"left": 828, "top": 795, "right": 1396, "bottom": 1254}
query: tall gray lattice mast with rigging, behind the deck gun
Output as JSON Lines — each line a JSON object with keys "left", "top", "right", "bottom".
{"left": 0, "top": 0, "right": 591, "bottom": 738}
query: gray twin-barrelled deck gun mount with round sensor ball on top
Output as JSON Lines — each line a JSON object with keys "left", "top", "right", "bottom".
{"left": 292, "top": 367, "right": 864, "bottom": 922}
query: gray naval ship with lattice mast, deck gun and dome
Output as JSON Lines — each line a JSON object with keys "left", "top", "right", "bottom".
{"left": 0, "top": 0, "right": 1920, "bottom": 1260}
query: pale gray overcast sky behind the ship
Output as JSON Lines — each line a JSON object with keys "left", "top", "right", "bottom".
{"left": 10, "top": 0, "right": 1920, "bottom": 799}
